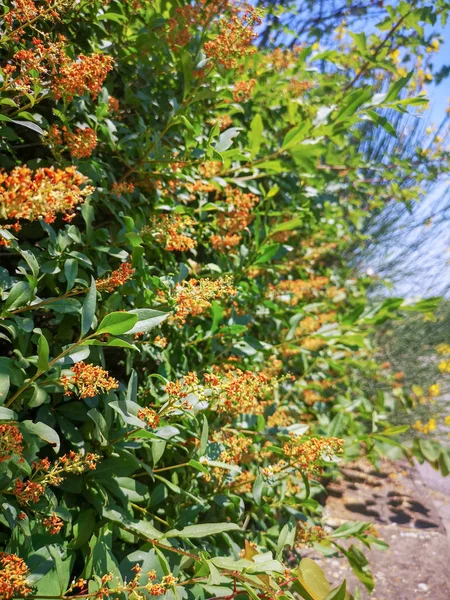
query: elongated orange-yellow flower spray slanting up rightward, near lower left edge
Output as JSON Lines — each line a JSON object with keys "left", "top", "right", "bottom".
{"left": 12, "top": 450, "right": 100, "bottom": 505}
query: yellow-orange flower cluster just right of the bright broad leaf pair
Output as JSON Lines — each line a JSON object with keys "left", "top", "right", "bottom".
{"left": 172, "top": 275, "right": 237, "bottom": 324}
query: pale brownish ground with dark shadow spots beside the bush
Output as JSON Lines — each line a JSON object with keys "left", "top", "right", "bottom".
{"left": 304, "top": 461, "right": 450, "bottom": 600}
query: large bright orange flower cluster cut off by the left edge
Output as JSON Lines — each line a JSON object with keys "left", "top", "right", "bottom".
{"left": 0, "top": 166, "right": 94, "bottom": 223}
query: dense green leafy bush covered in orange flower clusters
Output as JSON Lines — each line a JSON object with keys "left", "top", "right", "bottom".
{"left": 0, "top": 0, "right": 449, "bottom": 600}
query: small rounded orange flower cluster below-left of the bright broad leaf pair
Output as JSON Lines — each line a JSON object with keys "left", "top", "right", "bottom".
{"left": 60, "top": 361, "right": 119, "bottom": 398}
